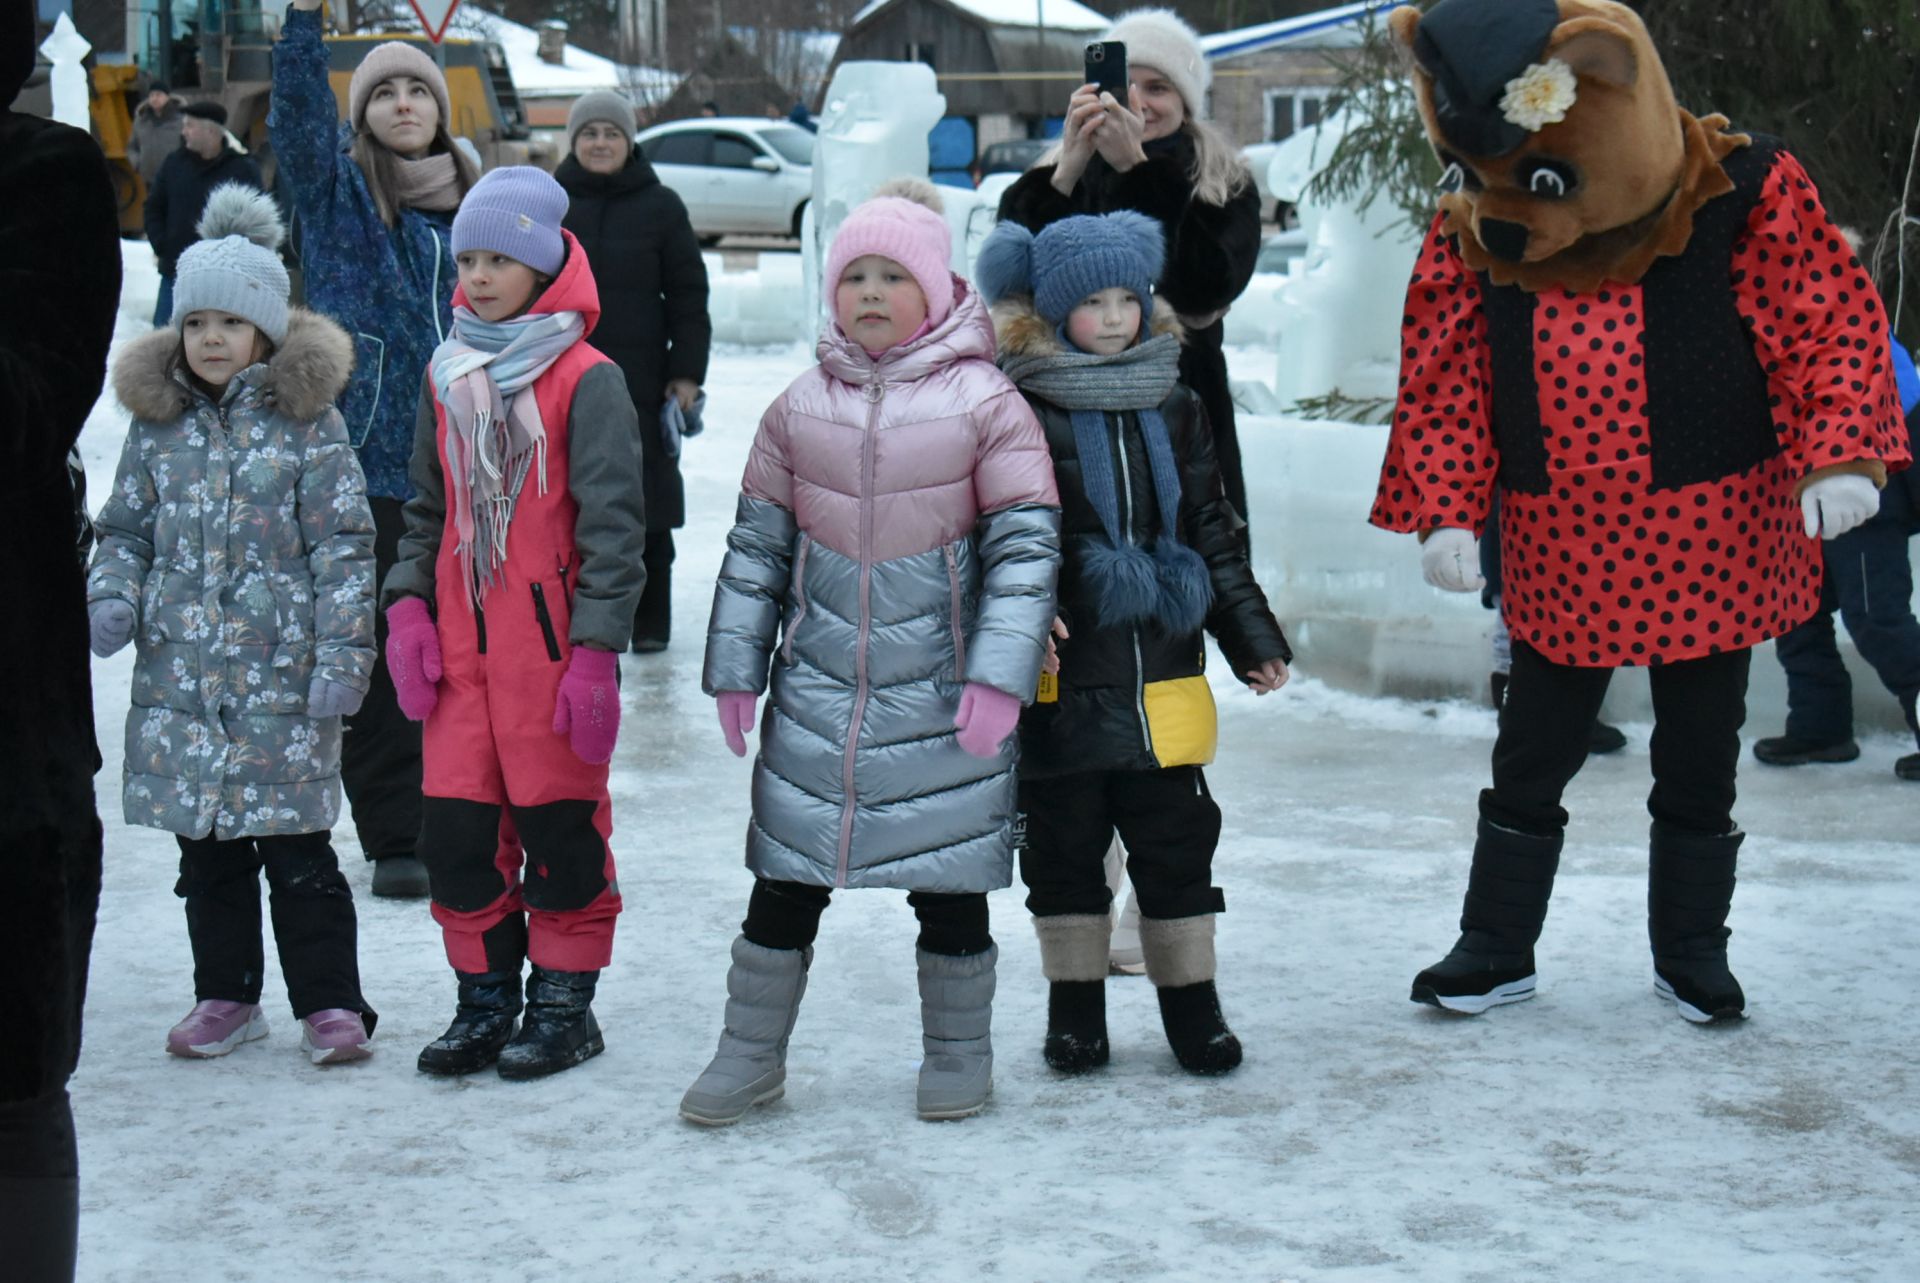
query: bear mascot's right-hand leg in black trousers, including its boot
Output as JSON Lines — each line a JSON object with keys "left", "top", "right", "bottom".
{"left": 1647, "top": 651, "right": 1753, "bottom": 1024}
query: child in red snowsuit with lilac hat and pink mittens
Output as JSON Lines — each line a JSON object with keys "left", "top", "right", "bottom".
{"left": 382, "top": 167, "right": 645, "bottom": 1077}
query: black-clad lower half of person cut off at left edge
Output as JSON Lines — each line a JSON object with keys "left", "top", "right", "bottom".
{"left": 0, "top": 814, "right": 100, "bottom": 1283}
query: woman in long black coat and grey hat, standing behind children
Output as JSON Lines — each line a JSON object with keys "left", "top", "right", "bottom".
{"left": 553, "top": 90, "right": 712, "bottom": 651}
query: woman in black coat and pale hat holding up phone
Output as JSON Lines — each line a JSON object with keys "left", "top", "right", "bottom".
{"left": 1000, "top": 10, "right": 1260, "bottom": 520}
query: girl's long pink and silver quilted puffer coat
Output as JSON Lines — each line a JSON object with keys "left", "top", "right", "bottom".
{"left": 705, "top": 277, "right": 1060, "bottom": 891}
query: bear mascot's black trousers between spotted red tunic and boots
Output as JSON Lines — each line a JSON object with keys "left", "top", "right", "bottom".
{"left": 1482, "top": 638, "right": 1753, "bottom": 837}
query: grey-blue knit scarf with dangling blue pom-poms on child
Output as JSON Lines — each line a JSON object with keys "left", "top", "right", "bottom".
{"left": 1000, "top": 334, "right": 1213, "bottom": 634}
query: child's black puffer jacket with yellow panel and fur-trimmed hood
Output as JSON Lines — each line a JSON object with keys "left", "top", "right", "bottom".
{"left": 995, "top": 300, "right": 1292, "bottom": 778}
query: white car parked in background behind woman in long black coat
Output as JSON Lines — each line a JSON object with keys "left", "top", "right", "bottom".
{"left": 634, "top": 115, "right": 814, "bottom": 244}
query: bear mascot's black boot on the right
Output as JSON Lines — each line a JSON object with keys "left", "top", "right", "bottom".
{"left": 1647, "top": 822, "right": 1747, "bottom": 1024}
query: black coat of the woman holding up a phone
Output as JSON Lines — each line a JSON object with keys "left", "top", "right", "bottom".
{"left": 1000, "top": 133, "right": 1260, "bottom": 517}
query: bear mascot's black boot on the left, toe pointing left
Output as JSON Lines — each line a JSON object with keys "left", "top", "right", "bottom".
{"left": 1409, "top": 818, "right": 1563, "bottom": 1016}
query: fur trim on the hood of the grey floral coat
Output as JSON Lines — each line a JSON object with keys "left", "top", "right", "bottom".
{"left": 113, "top": 307, "right": 353, "bottom": 423}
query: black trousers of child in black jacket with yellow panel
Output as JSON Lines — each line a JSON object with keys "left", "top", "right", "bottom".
{"left": 1020, "top": 766, "right": 1227, "bottom": 918}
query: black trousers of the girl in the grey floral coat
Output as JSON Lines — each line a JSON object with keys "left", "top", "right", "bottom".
{"left": 173, "top": 830, "right": 374, "bottom": 1033}
